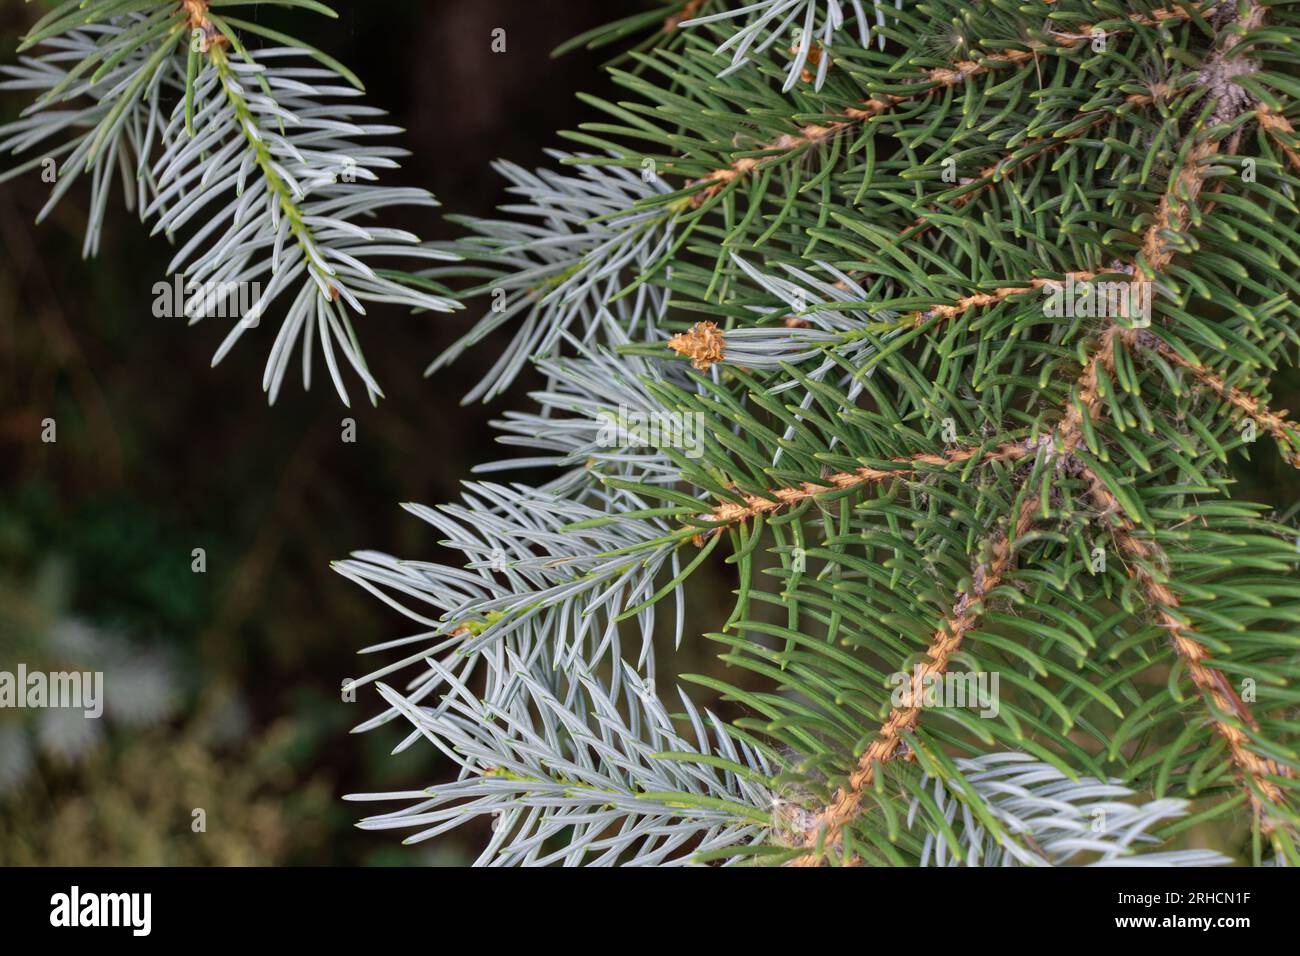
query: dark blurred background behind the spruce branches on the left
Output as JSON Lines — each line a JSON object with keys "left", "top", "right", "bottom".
{"left": 0, "top": 0, "right": 644, "bottom": 865}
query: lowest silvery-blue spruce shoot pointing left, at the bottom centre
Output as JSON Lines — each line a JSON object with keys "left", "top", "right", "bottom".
{"left": 348, "top": 652, "right": 775, "bottom": 866}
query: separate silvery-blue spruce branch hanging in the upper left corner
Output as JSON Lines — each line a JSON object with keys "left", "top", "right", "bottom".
{"left": 0, "top": 0, "right": 459, "bottom": 405}
